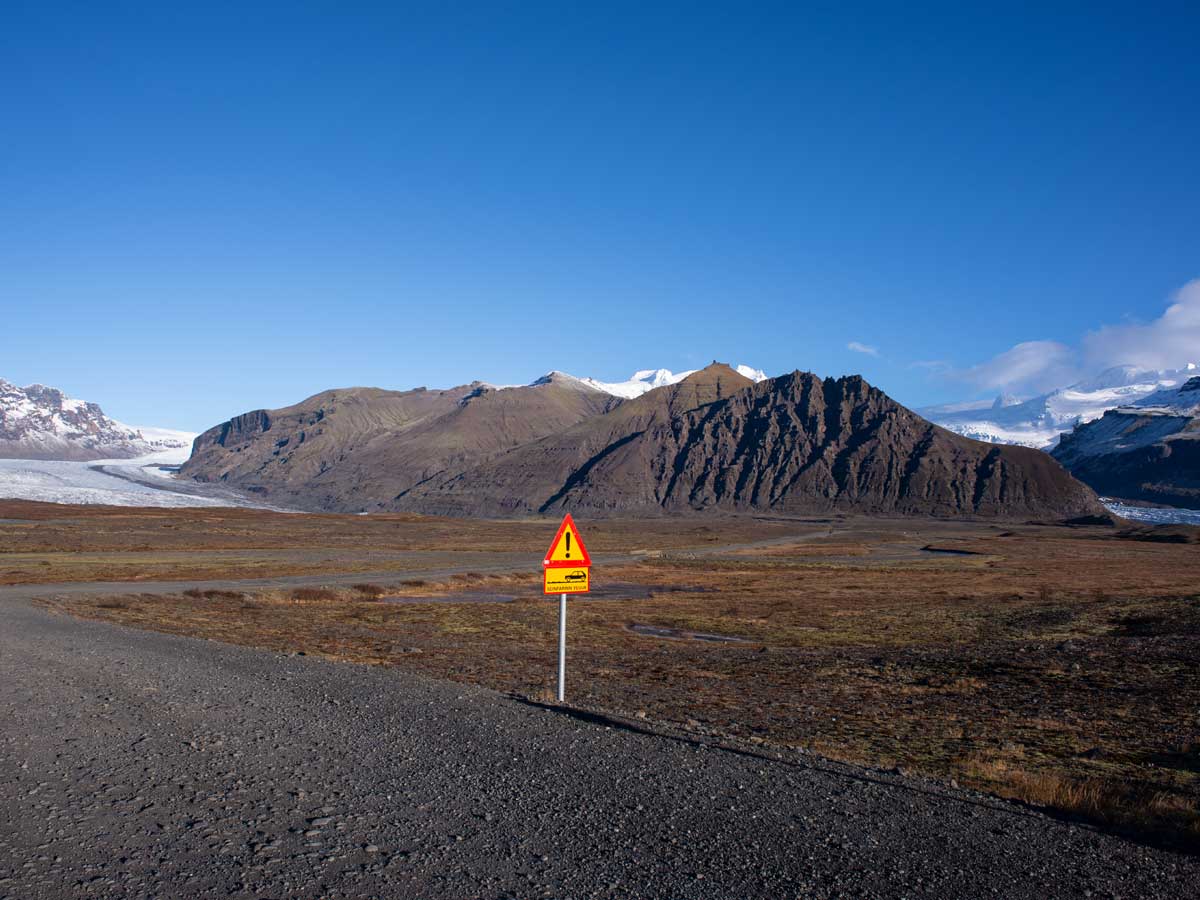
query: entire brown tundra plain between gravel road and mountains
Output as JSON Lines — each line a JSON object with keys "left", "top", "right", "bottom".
{"left": 0, "top": 502, "right": 1200, "bottom": 850}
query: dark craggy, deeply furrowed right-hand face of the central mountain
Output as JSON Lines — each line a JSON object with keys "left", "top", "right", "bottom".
{"left": 551, "top": 372, "right": 1098, "bottom": 517}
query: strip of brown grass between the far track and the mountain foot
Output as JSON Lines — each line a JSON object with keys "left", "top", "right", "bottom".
{"left": 0, "top": 500, "right": 797, "bottom": 584}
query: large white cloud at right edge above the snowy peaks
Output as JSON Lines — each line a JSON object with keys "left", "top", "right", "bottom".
{"left": 1084, "top": 278, "right": 1200, "bottom": 370}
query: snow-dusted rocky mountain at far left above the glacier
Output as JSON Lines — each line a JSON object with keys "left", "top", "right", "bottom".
{"left": 0, "top": 379, "right": 194, "bottom": 460}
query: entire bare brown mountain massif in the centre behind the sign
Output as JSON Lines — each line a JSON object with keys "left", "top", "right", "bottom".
{"left": 185, "top": 364, "right": 1104, "bottom": 520}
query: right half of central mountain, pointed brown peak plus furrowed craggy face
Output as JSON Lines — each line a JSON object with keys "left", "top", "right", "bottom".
{"left": 400, "top": 366, "right": 1103, "bottom": 518}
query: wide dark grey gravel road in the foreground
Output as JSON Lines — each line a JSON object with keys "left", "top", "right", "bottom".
{"left": 0, "top": 590, "right": 1200, "bottom": 900}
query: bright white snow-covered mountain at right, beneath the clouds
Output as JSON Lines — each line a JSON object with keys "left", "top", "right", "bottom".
{"left": 917, "top": 362, "right": 1200, "bottom": 448}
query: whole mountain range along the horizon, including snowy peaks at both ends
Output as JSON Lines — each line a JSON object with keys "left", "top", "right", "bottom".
{"left": 9, "top": 364, "right": 1200, "bottom": 517}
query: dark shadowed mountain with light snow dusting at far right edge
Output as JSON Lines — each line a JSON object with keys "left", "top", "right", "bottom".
{"left": 1054, "top": 377, "right": 1200, "bottom": 509}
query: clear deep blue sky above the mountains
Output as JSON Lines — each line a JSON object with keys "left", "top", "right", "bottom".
{"left": 0, "top": 0, "right": 1200, "bottom": 428}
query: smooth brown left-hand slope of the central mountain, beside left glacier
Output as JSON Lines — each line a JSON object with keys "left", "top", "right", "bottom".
{"left": 182, "top": 376, "right": 617, "bottom": 511}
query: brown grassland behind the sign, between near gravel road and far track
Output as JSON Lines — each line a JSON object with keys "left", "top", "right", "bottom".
{"left": 16, "top": 501, "right": 1200, "bottom": 847}
